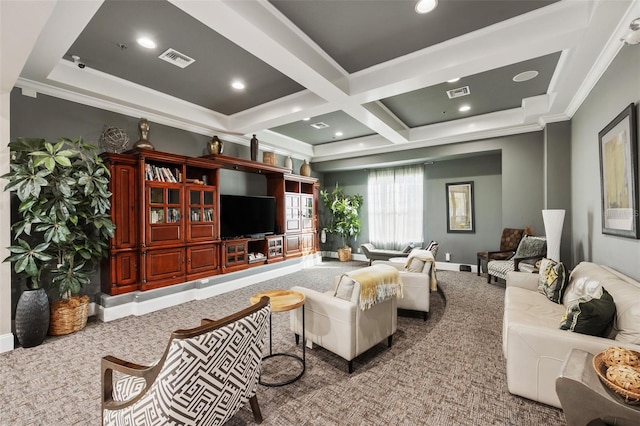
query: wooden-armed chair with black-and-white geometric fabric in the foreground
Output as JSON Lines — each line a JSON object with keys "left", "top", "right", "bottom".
{"left": 101, "top": 297, "right": 271, "bottom": 425}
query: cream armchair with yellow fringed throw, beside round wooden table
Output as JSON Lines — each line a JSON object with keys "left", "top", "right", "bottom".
{"left": 290, "top": 265, "right": 402, "bottom": 373}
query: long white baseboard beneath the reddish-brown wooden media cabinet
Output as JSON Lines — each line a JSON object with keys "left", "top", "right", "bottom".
{"left": 95, "top": 255, "right": 322, "bottom": 322}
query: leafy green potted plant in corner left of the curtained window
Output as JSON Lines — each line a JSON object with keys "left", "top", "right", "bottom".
{"left": 320, "top": 183, "right": 364, "bottom": 261}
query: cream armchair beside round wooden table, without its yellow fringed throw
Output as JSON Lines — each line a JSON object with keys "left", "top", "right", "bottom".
{"left": 290, "top": 276, "right": 398, "bottom": 373}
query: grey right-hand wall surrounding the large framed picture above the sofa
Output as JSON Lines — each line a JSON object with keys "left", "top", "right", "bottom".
{"left": 571, "top": 45, "right": 640, "bottom": 279}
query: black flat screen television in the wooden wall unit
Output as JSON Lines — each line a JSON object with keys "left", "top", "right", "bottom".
{"left": 220, "top": 194, "right": 276, "bottom": 239}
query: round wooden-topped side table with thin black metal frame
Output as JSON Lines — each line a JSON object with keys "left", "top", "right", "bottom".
{"left": 250, "top": 290, "right": 306, "bottom": 386}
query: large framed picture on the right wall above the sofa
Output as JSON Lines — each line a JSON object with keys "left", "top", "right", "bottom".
{"left": 598, "top": 104, "right": 640, "bottom": 238}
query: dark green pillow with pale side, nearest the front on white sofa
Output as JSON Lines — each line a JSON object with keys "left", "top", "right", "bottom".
{"left": 560, "top": 288, "right": 616, "bottom": 337}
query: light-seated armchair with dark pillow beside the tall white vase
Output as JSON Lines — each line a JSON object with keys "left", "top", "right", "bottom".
{"left": 487, "top": 235, "right": 547, "bottom": 283}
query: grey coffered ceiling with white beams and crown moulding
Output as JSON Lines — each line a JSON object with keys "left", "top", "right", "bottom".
{"left": 2, "top": 0, "right": 639, "bottom": 166}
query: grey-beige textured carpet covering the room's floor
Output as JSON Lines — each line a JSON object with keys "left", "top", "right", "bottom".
{"left": 0, "top": 261, "right": 565, "bottom": 426}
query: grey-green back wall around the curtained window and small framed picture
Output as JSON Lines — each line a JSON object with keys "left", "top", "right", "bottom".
{"left": 320, "top": 132, "right": 544, "bottom": 265}
